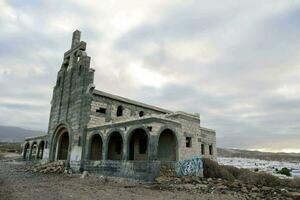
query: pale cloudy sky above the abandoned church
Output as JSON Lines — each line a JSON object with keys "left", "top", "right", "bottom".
{"left": 0, "top": 0, "right": 300, "bottom": 152}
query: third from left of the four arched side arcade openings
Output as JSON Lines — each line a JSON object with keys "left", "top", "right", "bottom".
{"left": 129, "top": 129, "right": 148, "bottom": 160}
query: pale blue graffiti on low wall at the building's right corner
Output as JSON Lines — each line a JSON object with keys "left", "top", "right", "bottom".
{"left": 175, "top": 156, "right": 203, "bottom": 176}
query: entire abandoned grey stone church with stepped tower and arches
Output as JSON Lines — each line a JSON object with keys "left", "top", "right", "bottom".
{"left": 23, "top": 30, "right": 217, "bottom": 178}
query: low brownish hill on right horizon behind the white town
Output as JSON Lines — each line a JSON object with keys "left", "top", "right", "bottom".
{"left": 218, "top": 148, "right": 300, "bottom": 162}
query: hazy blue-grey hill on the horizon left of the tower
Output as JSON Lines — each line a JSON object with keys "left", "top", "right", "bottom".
{"left": 0, "top": 126, "right": 45, "bottom": 142}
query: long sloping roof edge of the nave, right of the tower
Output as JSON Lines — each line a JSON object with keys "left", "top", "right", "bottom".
{"left": 93, "top": 89, "right": 174, "bottom": 113}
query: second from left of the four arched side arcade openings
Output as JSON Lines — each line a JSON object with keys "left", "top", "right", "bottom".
{"left": 107, "top": 132, "right": 123, "bottom": 160}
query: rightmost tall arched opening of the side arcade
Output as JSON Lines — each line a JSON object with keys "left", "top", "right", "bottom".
{"left": 158, "top": 129, "right": 177, "bottom": 161}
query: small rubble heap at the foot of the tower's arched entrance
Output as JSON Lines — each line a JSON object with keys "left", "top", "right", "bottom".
{"left": 25, "top": 161, "right": 66, "bottom": 174}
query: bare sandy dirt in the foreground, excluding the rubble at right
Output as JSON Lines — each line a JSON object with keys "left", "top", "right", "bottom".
{"left": 0, "top": 156, "right": 245, "bottom": 200}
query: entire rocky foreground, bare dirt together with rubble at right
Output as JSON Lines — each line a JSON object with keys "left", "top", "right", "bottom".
{"left": 0, "top": 156, "right": 300, "bottom": 200}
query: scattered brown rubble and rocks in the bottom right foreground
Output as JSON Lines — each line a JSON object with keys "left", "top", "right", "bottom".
{"left": 153, "top": 175, "right": 300, "bottom": 200}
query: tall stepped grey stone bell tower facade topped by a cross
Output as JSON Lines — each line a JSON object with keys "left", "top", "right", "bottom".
{"left": 48, "top": 30, "right": 94, "bottom": 166}
